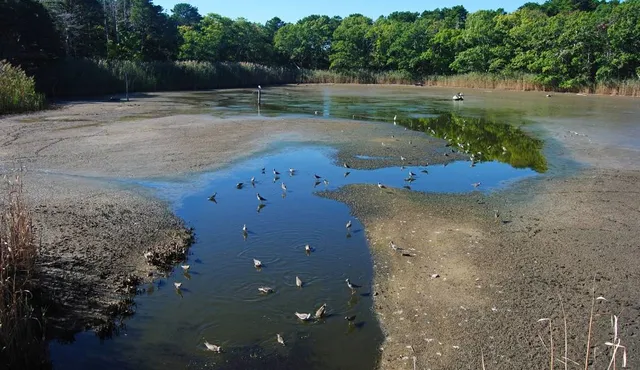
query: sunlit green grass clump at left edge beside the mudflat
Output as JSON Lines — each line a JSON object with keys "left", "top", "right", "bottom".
{"left": 0, "top": 60, "right": 45, "bottom": 114}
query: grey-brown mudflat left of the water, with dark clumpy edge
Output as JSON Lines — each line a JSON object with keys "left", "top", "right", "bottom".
{"left": 0, "top": 93, "right": 456, "bottom": 333}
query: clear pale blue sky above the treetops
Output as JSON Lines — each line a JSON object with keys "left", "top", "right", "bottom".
{"left": 154, "top": 0, "right": 543, "bottom": 23}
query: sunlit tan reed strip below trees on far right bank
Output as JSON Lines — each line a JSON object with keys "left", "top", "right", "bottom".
{"left": 303, "top": 70, "right": 640, "bottom": 96}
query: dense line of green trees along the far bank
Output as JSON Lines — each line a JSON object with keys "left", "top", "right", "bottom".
{"left": 0, "top": 0, "right": 640, "bottom": 89}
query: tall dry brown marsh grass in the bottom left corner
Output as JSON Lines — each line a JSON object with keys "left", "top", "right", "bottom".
{"left": 0, "top": 177, "right": 48, "bottom": 369}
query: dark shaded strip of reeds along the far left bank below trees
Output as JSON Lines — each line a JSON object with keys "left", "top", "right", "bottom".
{"left": 36, "top": 59, "right": 296, "bottom": 97}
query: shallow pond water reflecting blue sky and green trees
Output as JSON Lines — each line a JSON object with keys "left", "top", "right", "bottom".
{"left": 51, "top": 88, "right": 547, "bottom": 370}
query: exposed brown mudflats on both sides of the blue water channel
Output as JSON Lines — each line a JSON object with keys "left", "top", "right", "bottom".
{"left": 0, "top": 89, "right": 640, "bottom": 369}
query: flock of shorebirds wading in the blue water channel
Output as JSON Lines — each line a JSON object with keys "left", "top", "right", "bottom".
{"left": 173, "top": 163, "right": 370, "bottom": 353}
